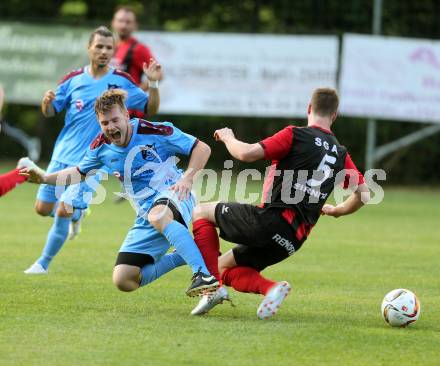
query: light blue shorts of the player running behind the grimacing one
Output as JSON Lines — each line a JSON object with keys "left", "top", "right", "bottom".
{"left": 37, "top": 160, "right": 102, "bottom": 210}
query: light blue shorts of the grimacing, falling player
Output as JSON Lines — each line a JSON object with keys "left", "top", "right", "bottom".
{"left": 119, "top": 191, "right": 195, "bottom": 262}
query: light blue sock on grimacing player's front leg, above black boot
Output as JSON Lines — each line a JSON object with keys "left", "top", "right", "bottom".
{"left": 163, "top": 220, "right": 210, "bottom": 274}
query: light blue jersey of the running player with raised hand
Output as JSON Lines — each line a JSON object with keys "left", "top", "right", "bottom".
{"left": 51, "top": 67, "right": 148, "bottom": 166}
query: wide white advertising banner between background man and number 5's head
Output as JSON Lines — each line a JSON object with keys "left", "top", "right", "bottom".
{"left": 136, "top": 32, "right": 339, "bottom": 117}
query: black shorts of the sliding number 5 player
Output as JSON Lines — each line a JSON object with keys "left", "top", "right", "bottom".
{"left": 215, "top": 202, "right": 301, "bottom": 271}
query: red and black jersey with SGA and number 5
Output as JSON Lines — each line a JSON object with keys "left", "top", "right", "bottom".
{"left": 260, "top": 126, "right": 364, "bottom": 242}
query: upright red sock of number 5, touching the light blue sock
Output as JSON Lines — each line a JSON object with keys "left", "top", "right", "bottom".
{"left": 193, "top": 219, "right": 221, "bottom": 280}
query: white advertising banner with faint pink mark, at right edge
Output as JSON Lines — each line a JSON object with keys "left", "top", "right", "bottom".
{"left": 339, "top": 34, "right": 440, "bottom": 123}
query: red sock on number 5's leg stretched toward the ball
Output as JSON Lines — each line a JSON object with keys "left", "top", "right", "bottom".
{"left": 222, "top": 267, "right": 276, "bottom": 295}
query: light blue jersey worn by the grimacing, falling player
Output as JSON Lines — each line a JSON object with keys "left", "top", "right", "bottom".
{"left": 78, "top": 118, "right": 197, "bottom": 216}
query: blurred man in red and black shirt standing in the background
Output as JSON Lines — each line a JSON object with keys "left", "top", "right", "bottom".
{"left": 112, "top": 5, "right": 157, "bottom": 90}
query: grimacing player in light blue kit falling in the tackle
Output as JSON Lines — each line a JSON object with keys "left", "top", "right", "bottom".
{"left": 22, "top": 89, "right": 219, "bottom": 296}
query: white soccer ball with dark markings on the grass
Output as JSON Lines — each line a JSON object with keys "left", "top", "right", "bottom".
{"left": 381, "top": 288, "right": 421, "bottom": 327}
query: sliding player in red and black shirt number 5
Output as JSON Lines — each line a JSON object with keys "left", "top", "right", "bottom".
{"left": 191, "top": 88, "right": 370, "bottom": 319}
